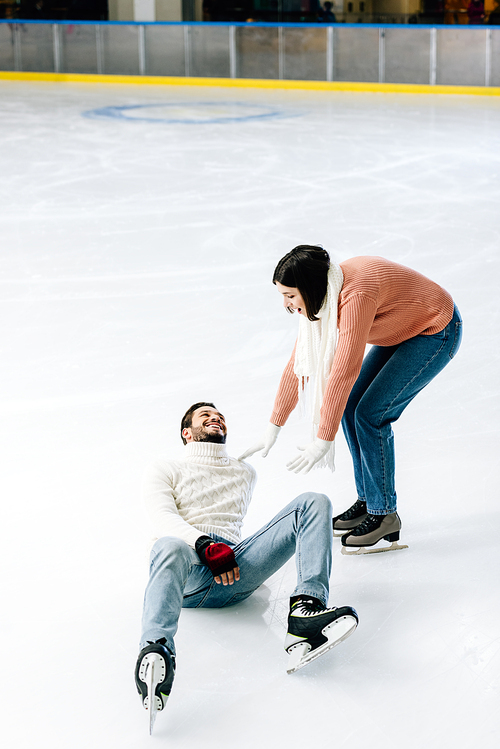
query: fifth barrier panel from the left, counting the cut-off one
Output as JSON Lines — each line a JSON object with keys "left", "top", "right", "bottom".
{"left": 144, "top": 24, "right": 186, "bottom": 76}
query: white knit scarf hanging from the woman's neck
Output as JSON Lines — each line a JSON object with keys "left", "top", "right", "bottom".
{"left": 293, "top": 262, "right": 344, "bottom": 471}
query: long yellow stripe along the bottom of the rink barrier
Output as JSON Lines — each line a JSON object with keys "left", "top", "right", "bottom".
{"left": 0, "top": 71, "right": 500, "bottom": 96}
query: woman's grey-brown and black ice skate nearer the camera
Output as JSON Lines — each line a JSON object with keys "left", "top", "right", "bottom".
{"left": 341, "top": 512, "right": 408, "bottom": 555}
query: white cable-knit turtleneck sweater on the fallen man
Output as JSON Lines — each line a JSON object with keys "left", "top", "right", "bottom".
{"left": 143, "top": 442, "right": 256, "bottom": 548}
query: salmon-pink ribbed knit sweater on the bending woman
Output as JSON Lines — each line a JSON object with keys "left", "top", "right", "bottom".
{"left": 270, "top": 257, "right": 453, "bottom": 441}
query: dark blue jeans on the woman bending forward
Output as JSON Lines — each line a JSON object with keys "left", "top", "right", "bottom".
{"left": 342, "top": 307, "right": 462, "bottom": 515}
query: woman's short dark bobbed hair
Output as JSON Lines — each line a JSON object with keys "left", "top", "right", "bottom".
{"left": 273, "top": 244, "right": 330, "bottom": 321}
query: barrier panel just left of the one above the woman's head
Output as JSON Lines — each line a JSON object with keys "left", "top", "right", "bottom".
{"left": 236, "top": 25, "right": 280, "bottom": 78}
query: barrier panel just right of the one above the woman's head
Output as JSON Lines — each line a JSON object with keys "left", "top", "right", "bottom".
{"left": 333, "top": 26, "right": 379, "bottom": 83}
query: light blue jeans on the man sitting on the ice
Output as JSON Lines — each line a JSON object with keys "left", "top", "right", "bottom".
{"left": 140, "top": 492, "right": 332, "bottom": 654}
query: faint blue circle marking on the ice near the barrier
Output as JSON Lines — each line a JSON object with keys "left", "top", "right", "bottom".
{"left": 83, "top": 101, "right": 298, "bottom": 125}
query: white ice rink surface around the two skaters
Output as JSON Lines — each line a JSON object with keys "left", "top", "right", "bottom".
{"left": 0, "top": 82, "right": 500, "bottom": 749}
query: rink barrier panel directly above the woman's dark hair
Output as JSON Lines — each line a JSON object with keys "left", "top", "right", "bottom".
{"left": 283, "top": 27, "right": 326, "bottom": 81}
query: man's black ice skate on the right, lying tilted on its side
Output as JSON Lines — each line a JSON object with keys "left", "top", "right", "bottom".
{"left": 285, "top": 598, "right": 358, "bottom": 674}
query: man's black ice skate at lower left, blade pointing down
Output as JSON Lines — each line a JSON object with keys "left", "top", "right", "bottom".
{"left": 135, "top": 638, "right": 175, "bottom": 734}
